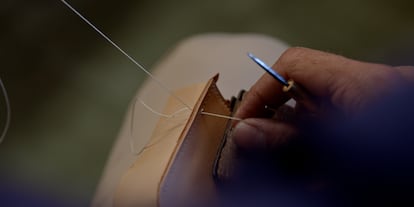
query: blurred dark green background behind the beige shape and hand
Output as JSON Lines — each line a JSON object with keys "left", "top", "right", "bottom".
{"left": 0, "top": 0, "right": 414, "bottom": 206}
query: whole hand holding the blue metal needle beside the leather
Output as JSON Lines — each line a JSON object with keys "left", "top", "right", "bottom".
{"left": 232, "top": 48, "right": 414, "bottom": 149}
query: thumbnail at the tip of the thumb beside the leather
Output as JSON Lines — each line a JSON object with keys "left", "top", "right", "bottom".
{"left": 231, "top": 121, "right": 266, "bottom": 150}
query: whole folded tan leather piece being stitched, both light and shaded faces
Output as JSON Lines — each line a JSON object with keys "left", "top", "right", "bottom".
{"left": 115, "top": 76, "right": 230, "bottom": 206}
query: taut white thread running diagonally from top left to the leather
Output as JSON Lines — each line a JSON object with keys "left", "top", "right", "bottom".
{"left": 60, "top": 0, "right": 192, "bottom": 110}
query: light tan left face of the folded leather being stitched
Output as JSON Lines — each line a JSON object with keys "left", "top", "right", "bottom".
{"left": 113, "top": 83, "right": 207, "bottom": 206}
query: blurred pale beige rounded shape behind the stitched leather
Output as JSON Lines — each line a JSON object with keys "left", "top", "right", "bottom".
{"left": 91, "top": 34, "right": 287, "bottom": 207}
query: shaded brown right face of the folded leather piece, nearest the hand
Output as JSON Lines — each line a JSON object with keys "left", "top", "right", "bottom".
{"left": 160, "top": 78, "right": 230, "bottom": 206}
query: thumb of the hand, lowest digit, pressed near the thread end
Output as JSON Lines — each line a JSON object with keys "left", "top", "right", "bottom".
{"left": 232, "top": 118, "right": 298, "bottom": 150}
